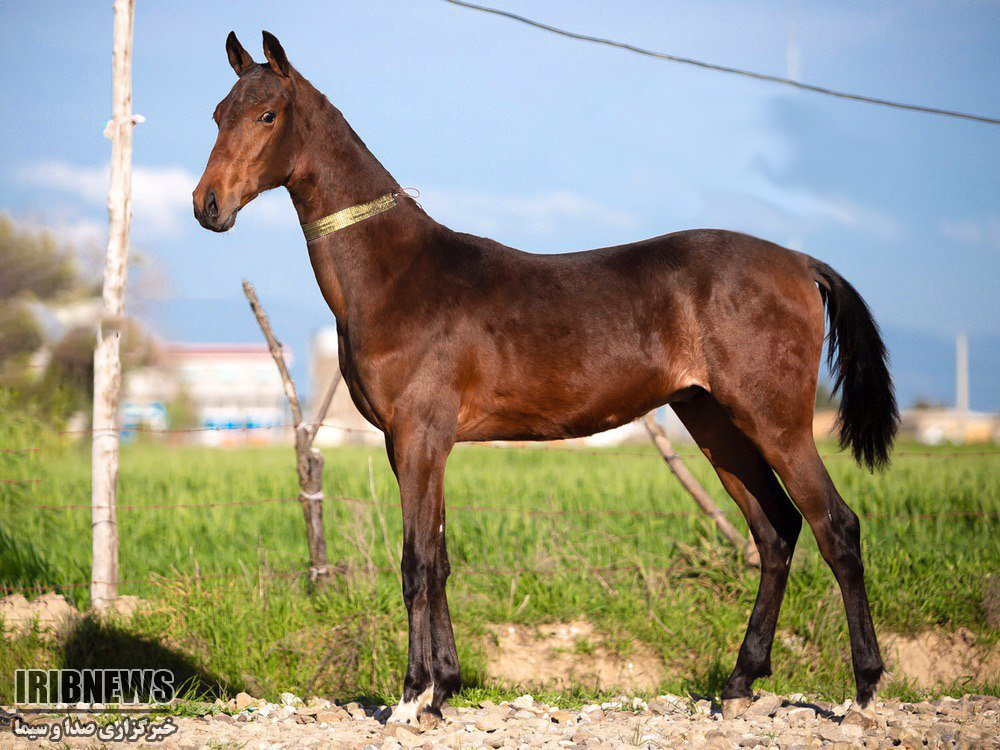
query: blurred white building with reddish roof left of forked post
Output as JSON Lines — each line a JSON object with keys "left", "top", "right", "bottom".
{"left": 121, "top": 344, "right": 291, "bottom": 445}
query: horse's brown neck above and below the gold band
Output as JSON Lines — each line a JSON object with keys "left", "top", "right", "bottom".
{"left": 287, "top": 89, "right": 436, "bottom": 326}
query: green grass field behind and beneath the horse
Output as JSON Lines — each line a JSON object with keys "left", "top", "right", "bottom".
{"left": 0, "top": 400, "right": 1000, "bottom": 702}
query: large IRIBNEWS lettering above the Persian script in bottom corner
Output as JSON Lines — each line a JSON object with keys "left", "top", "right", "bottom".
{"left": 14, "top": 669, "right": 174, "bottom": 713}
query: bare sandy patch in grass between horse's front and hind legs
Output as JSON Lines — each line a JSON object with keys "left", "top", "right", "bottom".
{"left": 486, "top": 620, "right": 667, "bottom": 691}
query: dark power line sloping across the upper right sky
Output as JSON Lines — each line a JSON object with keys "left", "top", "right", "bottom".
{"left": 445, "top": 0, "right": 1000, "bottom": 125}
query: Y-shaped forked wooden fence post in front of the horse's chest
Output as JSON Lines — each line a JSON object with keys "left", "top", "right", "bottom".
{"left": 243, "top": 281, "right": 340, "bottom": 581}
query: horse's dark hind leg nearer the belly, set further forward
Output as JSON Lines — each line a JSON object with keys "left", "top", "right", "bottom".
{"left": 673, "top": 394, "right": 802, "bottom": 718}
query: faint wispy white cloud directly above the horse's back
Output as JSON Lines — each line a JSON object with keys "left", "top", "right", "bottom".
{"left": 419, "top": 189, "right": 636, "bottom": 239}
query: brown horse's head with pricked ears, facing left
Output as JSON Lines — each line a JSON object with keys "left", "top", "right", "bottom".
{"left": 193, "top": 31, "right": 298, "bottom": 232}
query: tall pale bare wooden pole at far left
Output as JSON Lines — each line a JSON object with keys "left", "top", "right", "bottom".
{"left": 90, "top": 0, "right": 136, "bottom": 613}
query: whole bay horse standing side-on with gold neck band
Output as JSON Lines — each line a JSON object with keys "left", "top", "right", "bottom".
{"left": 193, "top": 31, "right": 898, "bottom": 727}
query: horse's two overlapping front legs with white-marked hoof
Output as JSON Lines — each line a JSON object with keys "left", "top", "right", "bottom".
{"left": 387, "top": 421, "right": 458, "bottom": 728}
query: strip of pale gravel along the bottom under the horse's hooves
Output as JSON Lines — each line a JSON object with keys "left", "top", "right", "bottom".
{"left": 0, "top": 693, "right": 1000, "bottom": 750}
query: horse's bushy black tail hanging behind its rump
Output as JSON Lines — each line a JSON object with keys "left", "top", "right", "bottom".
{"left": 810, "top": 258, "right": 899, "bottom": 470}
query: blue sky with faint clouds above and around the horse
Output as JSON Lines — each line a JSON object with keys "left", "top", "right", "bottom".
{"left": 0, "top": 0, "right": 1000, "bottom": 409}
